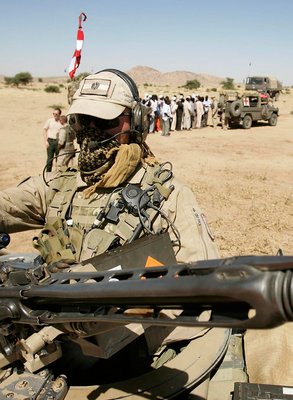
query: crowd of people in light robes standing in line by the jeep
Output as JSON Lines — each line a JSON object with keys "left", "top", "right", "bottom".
{"left": 143, "top": 93, "right": 218, "bottom": 136}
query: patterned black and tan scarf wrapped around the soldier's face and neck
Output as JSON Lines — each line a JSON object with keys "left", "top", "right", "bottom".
{"left": 76, "top": 127, "right": 142, "bottom": 197}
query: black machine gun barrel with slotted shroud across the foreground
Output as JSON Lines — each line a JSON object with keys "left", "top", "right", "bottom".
{"left": 0, "top": 256, "right": 293, "bottom": 329}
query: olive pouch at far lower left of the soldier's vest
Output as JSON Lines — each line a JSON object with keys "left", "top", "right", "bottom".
{"left": 33, "top": 218, "right": 75, "bottom": 264}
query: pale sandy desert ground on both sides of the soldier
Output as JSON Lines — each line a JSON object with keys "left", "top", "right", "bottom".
{"left": 0, "top": 86, "right": 293, "bottom": 257}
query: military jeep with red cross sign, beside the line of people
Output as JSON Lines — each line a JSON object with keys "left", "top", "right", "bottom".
{"left": 218, "top": 91, "right": 279, "bottom": 129}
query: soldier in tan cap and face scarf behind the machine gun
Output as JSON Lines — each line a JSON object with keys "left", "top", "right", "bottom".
{"left": 0, "top": 69, "right": 240, "bottom": 398}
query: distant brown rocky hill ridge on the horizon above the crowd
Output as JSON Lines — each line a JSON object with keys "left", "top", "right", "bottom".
{"left": 126, "top": 66, "right": 225, "bottom": 87}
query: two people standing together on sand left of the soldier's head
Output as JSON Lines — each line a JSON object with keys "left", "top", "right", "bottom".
{"left": 43, "top": 108, "right": 75, "bottom": 172}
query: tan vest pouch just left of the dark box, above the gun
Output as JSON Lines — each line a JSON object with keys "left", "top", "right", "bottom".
{"left": 80, "top": 228, "right": 119, "bottom": 261}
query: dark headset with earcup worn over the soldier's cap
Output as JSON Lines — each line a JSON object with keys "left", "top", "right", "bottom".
{"left": 97, "top": 68, "right": 148, "bottom": 143}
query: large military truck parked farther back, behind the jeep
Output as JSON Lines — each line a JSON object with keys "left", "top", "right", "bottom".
{"left": 245, "top": 76, "right": 282, "bottom": 100}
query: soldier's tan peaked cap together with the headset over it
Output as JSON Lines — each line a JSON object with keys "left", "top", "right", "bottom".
{"left": 67, "top": 69, "right": 148, "bottom": 143}
